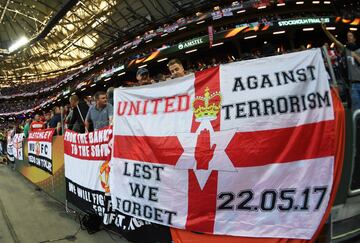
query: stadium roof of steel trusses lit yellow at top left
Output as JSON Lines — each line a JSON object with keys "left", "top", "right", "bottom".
{"left": 0, "top": 0, "right": 222, "bottom": 87}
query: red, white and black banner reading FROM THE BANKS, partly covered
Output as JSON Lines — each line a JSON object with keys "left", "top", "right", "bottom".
{"left": 64, "top": 127, "right": 149, "bottom": 232}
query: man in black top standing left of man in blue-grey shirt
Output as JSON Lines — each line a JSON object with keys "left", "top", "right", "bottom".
{"left": 68, "top": 95, "right": 89, "bottom": 133}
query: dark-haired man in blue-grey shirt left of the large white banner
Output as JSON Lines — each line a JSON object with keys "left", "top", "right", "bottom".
{"left": 85, "top": 91, "right": 113, "bottom": 131}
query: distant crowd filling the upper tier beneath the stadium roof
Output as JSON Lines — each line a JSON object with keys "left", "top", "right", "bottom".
{"left": 0, "top": 0, "right": 352, "bottom": 99}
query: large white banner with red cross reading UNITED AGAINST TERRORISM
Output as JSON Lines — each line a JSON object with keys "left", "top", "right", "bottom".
{"left": 110, "top": 49, "right": 335, "bottom": 239}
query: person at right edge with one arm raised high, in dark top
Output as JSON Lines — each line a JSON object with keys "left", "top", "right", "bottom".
{"left": 321, "top": 24, "right": 360, "bottom": 110}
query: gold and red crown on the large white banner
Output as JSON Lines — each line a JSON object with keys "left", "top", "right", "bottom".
{"left": 192, "top": 87, "right": 221, "bottom": 122}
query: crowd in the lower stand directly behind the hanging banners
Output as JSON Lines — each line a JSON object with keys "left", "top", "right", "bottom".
{"left": 0, "top": 27, "right": 360, "bottom": 140}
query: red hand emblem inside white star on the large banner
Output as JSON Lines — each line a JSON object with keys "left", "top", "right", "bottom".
{"left": 195, "top": 129, "right": 216, "bottom": 170}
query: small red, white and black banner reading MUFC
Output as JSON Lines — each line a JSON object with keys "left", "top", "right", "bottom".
{"left": 28, "top": 128, "right": 55, "bottom": 174}
